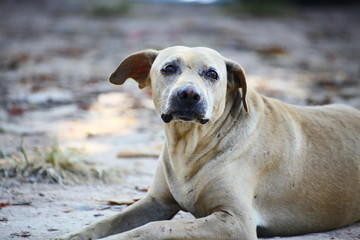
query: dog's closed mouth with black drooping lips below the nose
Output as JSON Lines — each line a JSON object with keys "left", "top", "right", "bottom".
{"left": 161, "top": 110, "right": 209, "bottom": 124}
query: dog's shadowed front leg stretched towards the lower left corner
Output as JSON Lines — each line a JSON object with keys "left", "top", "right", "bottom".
{"left": 55, "top": 194, "right": 179, "bottom": 240}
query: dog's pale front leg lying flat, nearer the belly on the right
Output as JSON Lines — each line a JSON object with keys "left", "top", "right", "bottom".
{"left": 103, "top": 211, "right": 257, "bottom": 240}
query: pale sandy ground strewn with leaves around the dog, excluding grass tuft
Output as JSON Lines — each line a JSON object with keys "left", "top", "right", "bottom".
{"left": 0, "top": 1, "right": 360, "bottom": 240}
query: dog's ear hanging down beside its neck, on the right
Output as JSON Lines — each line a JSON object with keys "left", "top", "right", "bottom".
{"left": 225, "top": 59, "right": 248, "bottom": 112}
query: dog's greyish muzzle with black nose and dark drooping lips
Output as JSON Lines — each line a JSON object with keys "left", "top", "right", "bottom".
{"left": 161, "top": 86, "right": 209, "bottom": 124}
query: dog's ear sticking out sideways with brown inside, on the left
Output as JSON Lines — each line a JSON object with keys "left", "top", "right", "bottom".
{"left": 109, "top": 50, "right": 159, "bottom": 88}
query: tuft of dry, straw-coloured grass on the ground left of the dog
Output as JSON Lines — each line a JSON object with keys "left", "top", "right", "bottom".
{"left": 0, "top": 140, "right": 121, "bottom": 184}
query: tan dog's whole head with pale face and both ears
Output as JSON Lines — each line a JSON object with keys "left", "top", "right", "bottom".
{"left": 110, "top": 46, "right": 247, "bottom": 124}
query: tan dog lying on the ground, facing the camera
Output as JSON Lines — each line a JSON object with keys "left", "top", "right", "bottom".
{"left": 56, "top": 47, "right": 360, "bottom": 240}
